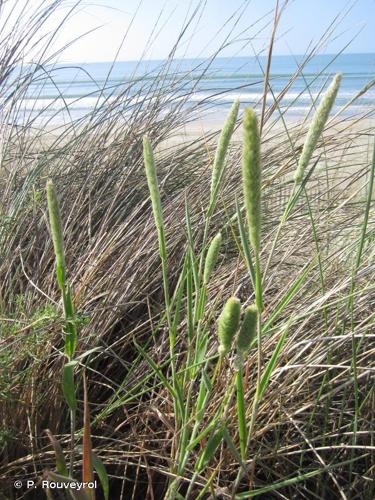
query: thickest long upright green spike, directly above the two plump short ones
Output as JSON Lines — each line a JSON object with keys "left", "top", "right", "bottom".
{"left": 242, "top": 108, "right": 261, "bottom": 252}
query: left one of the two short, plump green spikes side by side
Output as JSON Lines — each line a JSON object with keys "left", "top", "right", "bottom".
{"left": 217, "top": 297, "right": 241, "bottom": 355}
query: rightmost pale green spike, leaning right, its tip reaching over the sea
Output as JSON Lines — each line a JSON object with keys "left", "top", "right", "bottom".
{"left": 294, "top": 73, "right": 341, "bottom": 183}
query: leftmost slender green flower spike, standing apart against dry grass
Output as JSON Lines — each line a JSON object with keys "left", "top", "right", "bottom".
{"left": 46, "top": 179, "right": 65, "bottom": 291}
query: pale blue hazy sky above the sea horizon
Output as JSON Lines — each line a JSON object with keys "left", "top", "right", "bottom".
{"left": 33, "top": 0, "right": 375, "bottom": 62}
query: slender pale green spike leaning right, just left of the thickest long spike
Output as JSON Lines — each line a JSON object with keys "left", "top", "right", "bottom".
{"left": 210, "top": 99, "right": 240, "bottom": 204}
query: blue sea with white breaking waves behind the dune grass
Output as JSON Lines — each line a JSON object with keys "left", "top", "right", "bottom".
{"left": 11, "top": 53, "right": 375, "bottom": 122}
